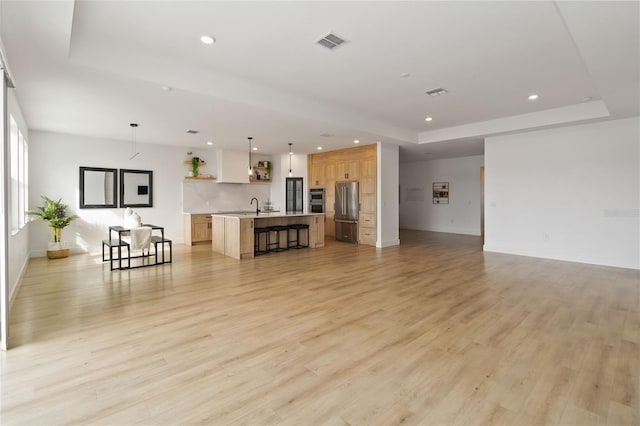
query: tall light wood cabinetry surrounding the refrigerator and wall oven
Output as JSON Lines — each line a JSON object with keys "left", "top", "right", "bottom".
{"left": 309, "top": 144, "right": 377, "bottom": 246}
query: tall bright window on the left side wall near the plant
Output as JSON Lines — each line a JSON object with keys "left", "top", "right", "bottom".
{"left": 9, "top": 115, "right": 29, "bottom": 234}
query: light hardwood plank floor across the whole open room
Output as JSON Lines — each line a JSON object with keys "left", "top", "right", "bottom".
{"left": 0, "top": 232, "right": 640, "bottom": 425}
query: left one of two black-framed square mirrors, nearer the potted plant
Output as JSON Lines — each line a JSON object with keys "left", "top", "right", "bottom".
{"left": 80, "top": 167, "right": 118, "bottom": 209}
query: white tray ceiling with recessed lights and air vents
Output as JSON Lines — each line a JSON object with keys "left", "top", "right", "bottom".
{"left": 0, "top": 1, "right": 640, "bottom": 161}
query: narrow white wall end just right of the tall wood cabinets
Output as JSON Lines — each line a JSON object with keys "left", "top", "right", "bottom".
{"left": 376, "top": 142, "right": 400, "bottom": 247}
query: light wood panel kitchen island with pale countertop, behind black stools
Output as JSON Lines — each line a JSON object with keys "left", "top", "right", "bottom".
{"left": 211, "top": 213, "right": 324, "bottom": 259}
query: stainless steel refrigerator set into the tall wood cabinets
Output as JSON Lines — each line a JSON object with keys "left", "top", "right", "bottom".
{"left": 334, "top": 182, "right": 360, "bottom": 243}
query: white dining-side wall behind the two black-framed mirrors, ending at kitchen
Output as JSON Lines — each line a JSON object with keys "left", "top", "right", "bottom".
{"left": 29, "top": 131, "right": 188, "bottom": 256}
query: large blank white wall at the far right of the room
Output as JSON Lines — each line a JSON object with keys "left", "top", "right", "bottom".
{"left": 485, "top": 118, "right": 640, "bottom": 269}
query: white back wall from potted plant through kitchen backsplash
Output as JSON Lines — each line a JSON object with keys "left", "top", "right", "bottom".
{"left": 28, "top": 131, "right": 290, "bottom": 256}
